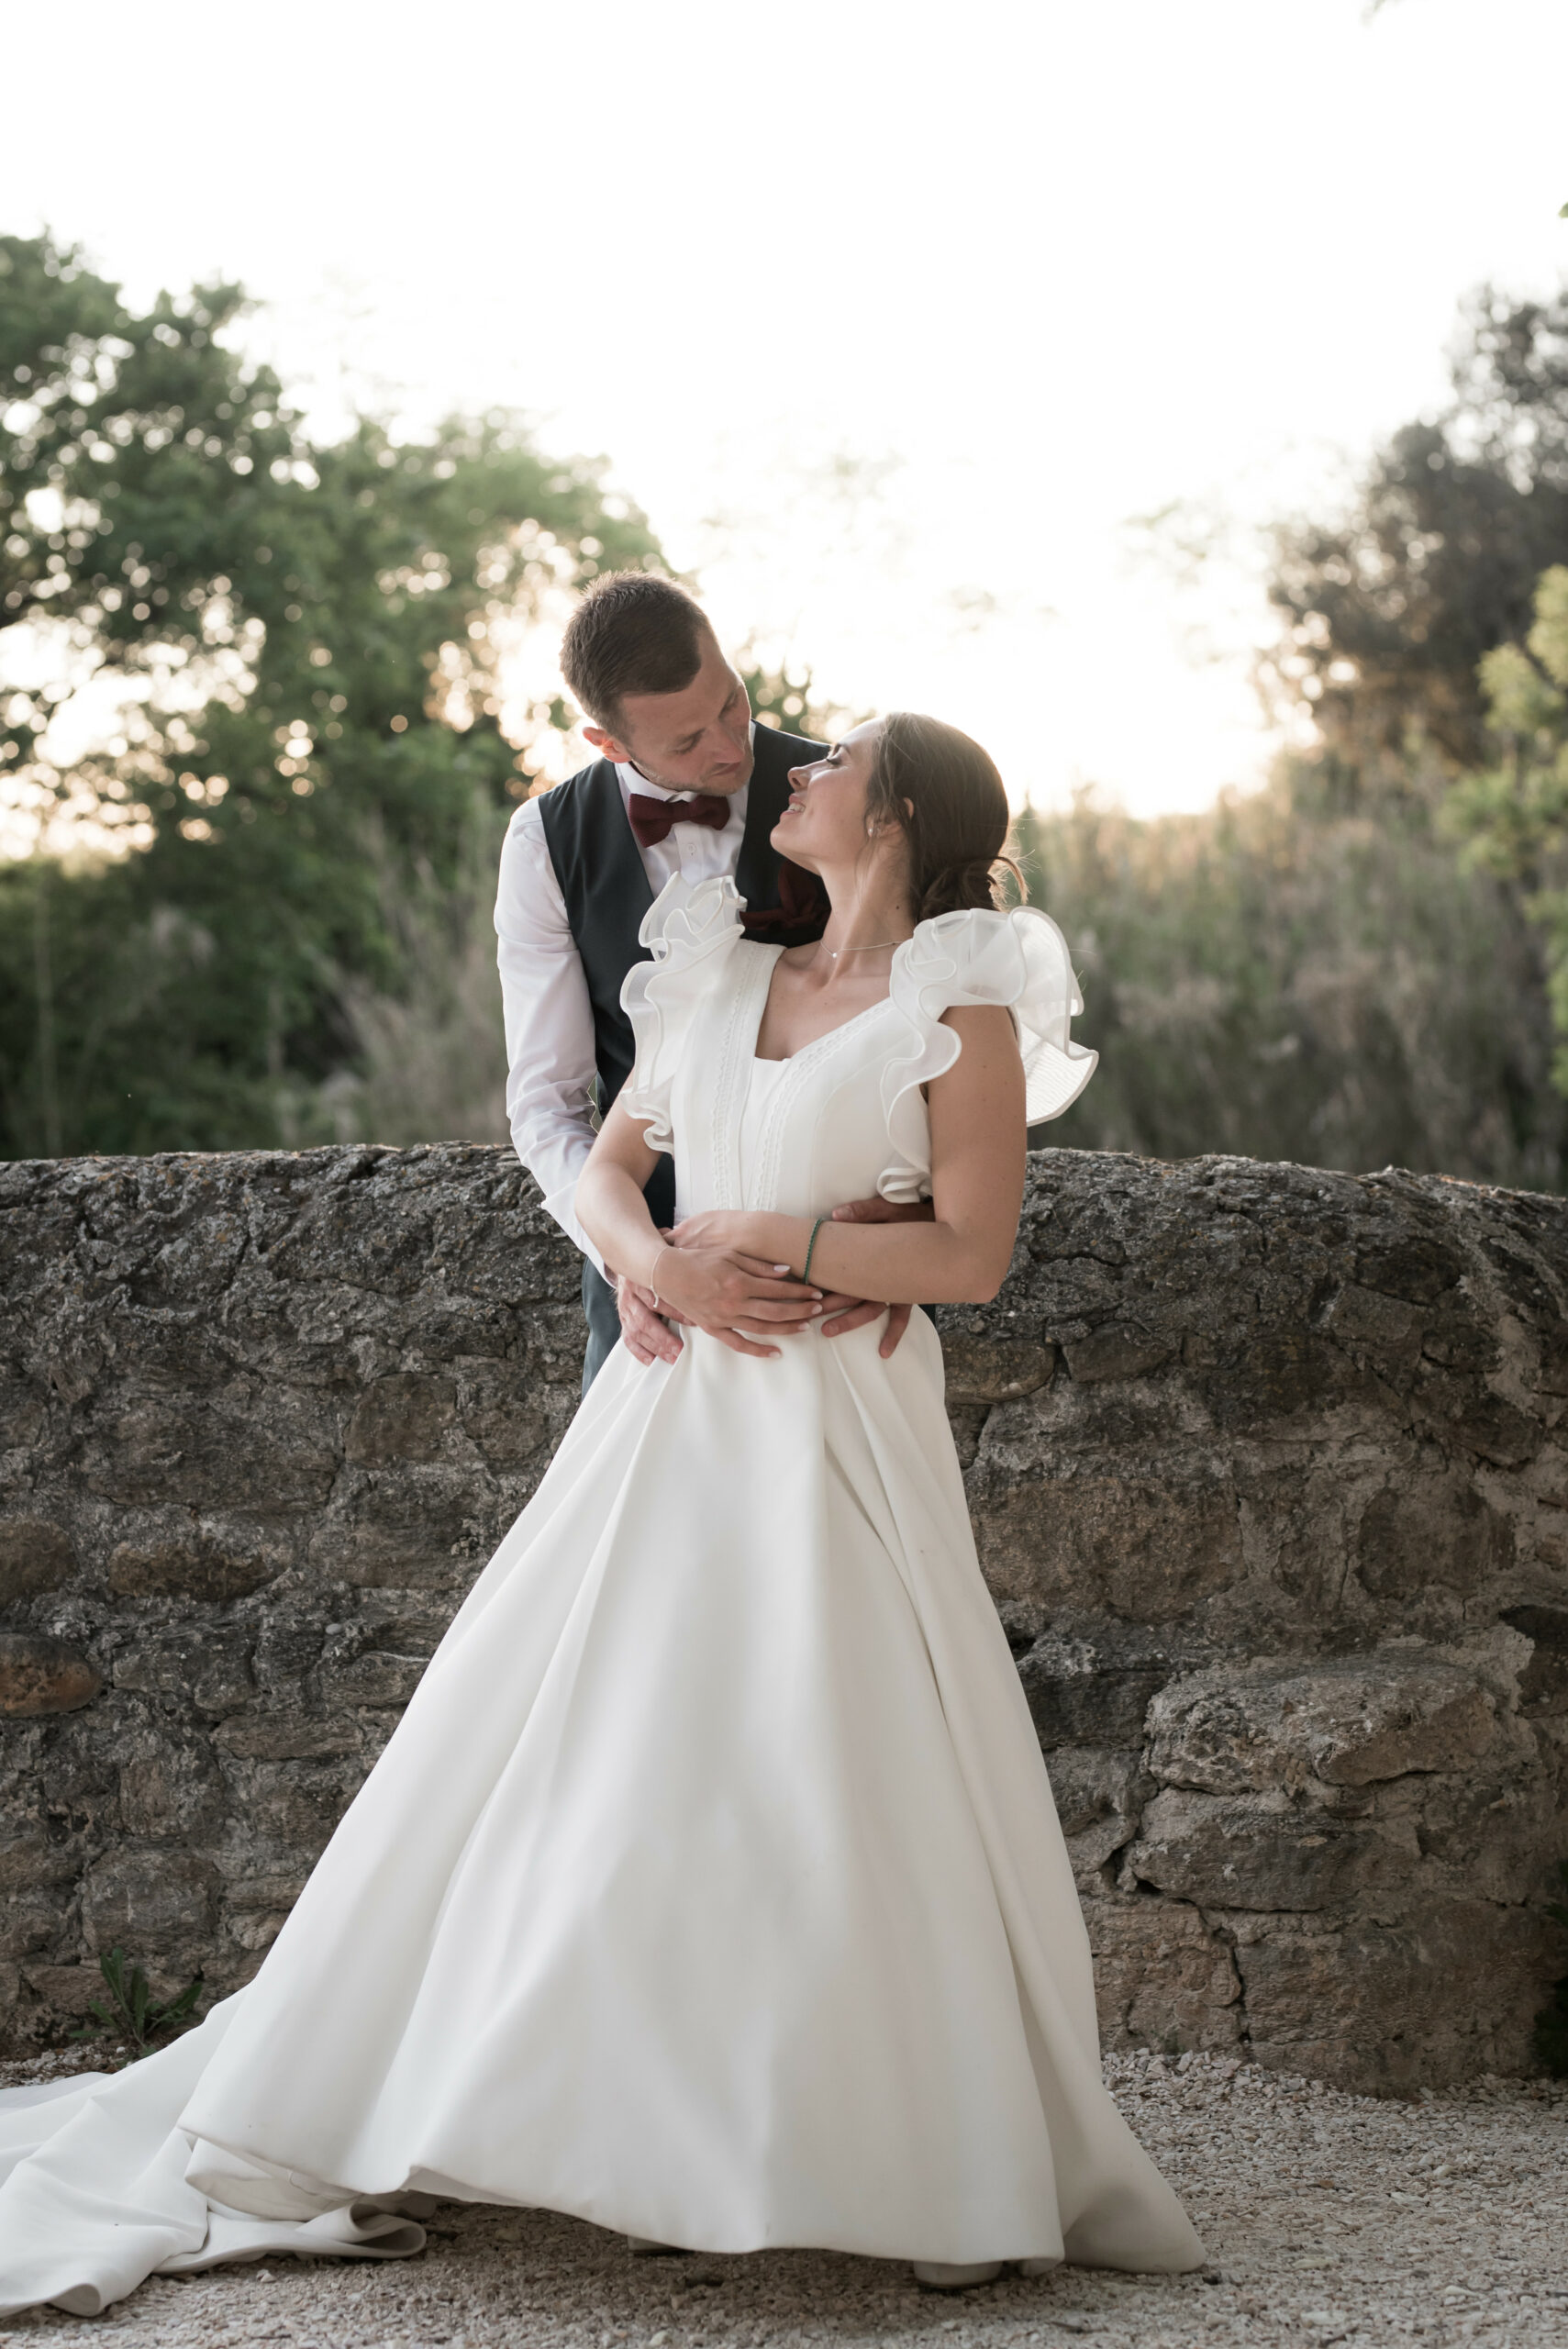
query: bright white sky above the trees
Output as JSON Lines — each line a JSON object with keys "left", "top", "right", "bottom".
{"left": 0, "top": 0, "right": 1568, "bottom": 813}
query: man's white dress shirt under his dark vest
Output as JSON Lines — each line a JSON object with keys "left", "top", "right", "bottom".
{"left": 495, "top": 747, "right": 749, "bottom": 1271}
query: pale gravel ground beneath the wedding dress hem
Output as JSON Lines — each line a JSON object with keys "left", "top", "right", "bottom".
{"left": 0, "top": 2055, "right": 1568, "bottom": 2349}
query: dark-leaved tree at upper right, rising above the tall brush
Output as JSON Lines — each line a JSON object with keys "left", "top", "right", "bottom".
{"left": 1265, "top": 289, "right": 1568, "bottom": 806}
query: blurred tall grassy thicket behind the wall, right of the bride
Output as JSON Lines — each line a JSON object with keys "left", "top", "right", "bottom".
{"left": 1017, "top": 759, "right": 1568, "bottom": 1191}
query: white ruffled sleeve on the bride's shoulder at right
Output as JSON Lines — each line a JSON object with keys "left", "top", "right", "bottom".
{"left": 878, "top": 905, "right": 1098, "bottom": 1203}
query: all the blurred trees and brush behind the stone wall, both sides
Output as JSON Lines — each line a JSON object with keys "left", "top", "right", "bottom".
{"left": 0, "top": 238, "right": 1568, "bottom": 1191}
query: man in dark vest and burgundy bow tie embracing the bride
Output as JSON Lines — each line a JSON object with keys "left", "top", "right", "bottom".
{"left": 495, "top": 571, "right": 917, "bottom": 1393}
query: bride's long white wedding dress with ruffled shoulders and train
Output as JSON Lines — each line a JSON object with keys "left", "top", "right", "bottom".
{"left": 0, "top": 881, "right": 1202, "bottom": 2314}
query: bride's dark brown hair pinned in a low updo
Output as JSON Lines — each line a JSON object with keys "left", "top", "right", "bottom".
{"left": 866, "top": 709, "right": 1029, "bottom": 921}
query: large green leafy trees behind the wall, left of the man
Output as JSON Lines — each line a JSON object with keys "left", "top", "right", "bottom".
{"left": 0, "top": 224, "right": 660, "bottom": 1156}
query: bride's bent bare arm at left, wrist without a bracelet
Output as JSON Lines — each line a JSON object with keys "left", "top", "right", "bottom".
{"left": 577, "top": 1102, "right": 821, "bottom": 1355}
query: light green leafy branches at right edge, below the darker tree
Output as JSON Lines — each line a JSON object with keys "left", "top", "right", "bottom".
{"left": 1443, "top": 563, "right": 1568, "bottom": 1092}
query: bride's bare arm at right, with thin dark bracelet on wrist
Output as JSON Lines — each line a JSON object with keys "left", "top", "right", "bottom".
{"left": 693, "top": 1006, "right": 1026, "bottom": 1304}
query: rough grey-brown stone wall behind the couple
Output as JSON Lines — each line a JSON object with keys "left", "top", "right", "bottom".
{"left": 0, "top": 1146, "right": 1568, "bottom": 2088}
